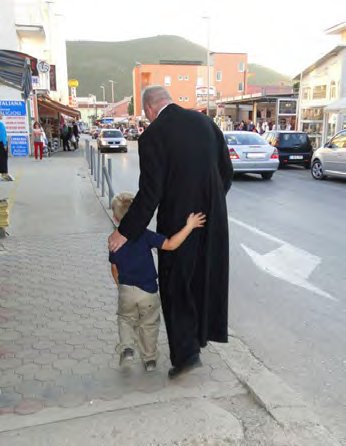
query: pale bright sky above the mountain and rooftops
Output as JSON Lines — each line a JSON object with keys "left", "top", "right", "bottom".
{"left": 60, "top": 0, "right": 346, "bottom": 76}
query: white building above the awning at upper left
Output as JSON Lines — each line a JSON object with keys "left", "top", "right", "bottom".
{"left": 0, "top": 0, "right": 69, "bottom": 104}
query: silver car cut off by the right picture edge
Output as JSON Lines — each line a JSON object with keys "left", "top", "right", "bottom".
{"left": 311, "top": 130, "right": 346, "bottom": 180}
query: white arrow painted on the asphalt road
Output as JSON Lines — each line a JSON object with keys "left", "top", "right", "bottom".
{"left": 228, "top": 217, "right": 338, "bottom": 302}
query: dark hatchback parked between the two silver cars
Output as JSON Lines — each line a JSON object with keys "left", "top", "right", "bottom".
{"left": 263, "top": 130, "right": 312, "bottom": 169}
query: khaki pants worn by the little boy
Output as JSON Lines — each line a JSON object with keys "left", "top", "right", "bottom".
{"left": 117, "top": 285, "right": 161, "bottom": 362}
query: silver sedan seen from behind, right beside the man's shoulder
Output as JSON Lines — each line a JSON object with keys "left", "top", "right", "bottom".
{"left": 224, "top": 131, "right": 279, "bottom": 180}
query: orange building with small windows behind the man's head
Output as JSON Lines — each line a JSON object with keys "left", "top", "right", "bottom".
{"left": 133, "top": 53, "right": 247, "bottom": 116}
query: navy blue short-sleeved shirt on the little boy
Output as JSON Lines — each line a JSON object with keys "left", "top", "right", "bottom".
{"left": 109, "top": 229, "right": 166, "bottom": 293}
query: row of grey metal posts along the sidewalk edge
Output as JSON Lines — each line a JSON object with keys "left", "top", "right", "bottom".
{"left": 85, "top": 140, "right": 114, "bottom": 209}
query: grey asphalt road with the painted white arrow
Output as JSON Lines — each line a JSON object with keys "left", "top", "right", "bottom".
{"left": 90, "top": 138, "right": 346, "bottom": 445}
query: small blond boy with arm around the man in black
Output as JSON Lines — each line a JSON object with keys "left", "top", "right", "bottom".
{"left": 109, "top": 192, "right": 206, "bottom": 372}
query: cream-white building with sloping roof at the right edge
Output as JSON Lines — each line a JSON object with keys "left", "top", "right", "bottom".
{"left": 295, "top": 22, "right": 346, "bottom": 147}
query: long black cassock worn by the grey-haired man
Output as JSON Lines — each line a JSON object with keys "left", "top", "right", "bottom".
{"left": 119, "top": 104, "right": 233, "bottom": 366}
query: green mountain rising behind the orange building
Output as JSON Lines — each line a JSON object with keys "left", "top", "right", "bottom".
{"left": 66, "top": 35, "right": 288, "bottom": 102}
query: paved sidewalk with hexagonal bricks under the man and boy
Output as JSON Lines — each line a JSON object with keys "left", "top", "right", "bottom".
{"left": 0, "top": 145, "right": 338, "bottom": 446}
